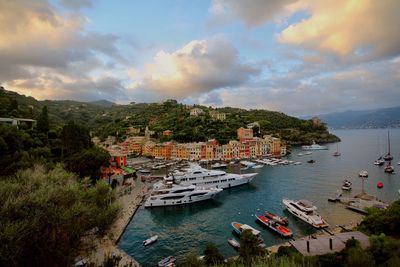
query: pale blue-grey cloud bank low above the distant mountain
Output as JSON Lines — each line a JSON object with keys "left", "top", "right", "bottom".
{"left": 201, "top": 58, "right": 400, "bottom": 116}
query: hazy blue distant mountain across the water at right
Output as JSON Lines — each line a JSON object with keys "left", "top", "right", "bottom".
{"left": 312, "top": 106, "right": 400, "bottom": 129}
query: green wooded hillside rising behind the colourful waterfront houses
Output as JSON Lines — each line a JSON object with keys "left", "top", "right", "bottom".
{"left": 0, "top": 89, "right": 339, "bottom": 144}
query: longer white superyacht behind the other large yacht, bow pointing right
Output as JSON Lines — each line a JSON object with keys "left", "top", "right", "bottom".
{"left": 153, "top": 164, "right": 257, "bottom": 189}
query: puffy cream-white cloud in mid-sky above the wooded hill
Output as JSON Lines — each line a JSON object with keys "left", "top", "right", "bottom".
{"left": 130, "top": 38, "right": 260, "bottom": 101}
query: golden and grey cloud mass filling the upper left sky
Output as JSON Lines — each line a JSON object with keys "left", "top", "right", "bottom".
{"left": 0, "top": 0, "right": 127, "bottom": 100}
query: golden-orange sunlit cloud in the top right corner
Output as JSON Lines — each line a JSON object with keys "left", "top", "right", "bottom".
{"left": 279, "top": 0, "right": 400, "bottom": 60}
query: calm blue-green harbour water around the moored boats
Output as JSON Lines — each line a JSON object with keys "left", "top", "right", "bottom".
{"left": 119, "top": 129, "right": 400, "bottom": 266}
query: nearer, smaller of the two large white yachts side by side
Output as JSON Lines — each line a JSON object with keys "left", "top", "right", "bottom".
{"left": 144, "top": 183, "right": 222, "bottom": 208}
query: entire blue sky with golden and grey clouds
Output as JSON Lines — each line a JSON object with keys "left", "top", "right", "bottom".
{"left": 0, "top": 0, "right": 400, "bottom": 116}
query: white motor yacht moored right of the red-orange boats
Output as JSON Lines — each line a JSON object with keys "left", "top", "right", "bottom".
{"left": 282, "top": 198, "right": 329, "bottom": 228}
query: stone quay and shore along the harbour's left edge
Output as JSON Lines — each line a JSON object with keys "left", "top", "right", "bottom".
{"left": 77, "top": 179, "right": 148, "bottom": 266}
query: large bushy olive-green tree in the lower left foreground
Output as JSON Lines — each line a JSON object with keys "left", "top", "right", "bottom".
{"left": 0, "top": 165, "right": 118, "bottom": 267}
